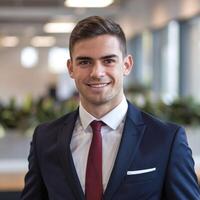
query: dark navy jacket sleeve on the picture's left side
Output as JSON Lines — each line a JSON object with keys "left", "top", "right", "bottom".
{"left": 20, "top": 128, "right": 48, "bottom": 200}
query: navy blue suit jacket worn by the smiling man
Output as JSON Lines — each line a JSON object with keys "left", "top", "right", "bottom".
{"left": 21, "top": 104, "right": 200, "bottom": 200}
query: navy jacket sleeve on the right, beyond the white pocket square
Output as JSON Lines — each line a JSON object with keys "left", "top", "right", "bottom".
{"left": 164, "top": 128, "right": 200, "bottom": 200}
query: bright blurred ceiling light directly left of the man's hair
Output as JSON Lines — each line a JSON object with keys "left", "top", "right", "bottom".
{"left": 44, "top": 22, "right": 75, "bottom": 33}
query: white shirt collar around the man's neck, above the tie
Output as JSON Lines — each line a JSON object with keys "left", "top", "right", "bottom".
{"left": 79, "top": 96, "right": 128, "bottom": 130}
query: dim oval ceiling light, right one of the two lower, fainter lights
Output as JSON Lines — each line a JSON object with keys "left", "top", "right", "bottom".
{"left": 31, "top": 36, "right": 56, "bottom": 47}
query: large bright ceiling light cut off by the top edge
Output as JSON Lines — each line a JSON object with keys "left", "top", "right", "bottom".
{"left": 65, "top": 0, "right": 114, "bottom": 7}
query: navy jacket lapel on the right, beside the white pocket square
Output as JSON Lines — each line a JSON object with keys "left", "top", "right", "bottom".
{"left": 104, "top": 104, "right": 145, "bottom": 200}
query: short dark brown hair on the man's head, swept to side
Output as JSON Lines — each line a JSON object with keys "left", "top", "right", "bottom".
{"left": 69, "top": 16, "right": 127, "bottom": 58}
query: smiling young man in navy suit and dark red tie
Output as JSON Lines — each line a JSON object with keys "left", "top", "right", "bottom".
{"left": 21, "top": 16, "right": 200, "bottom": 200}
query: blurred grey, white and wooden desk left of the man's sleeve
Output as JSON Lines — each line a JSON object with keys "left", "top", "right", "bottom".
{"left": 0, "top": 132, "right": 31, "bottom": 192}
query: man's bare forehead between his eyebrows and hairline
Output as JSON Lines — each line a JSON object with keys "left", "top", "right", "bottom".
{"left": 72, "top": 35, "right": 122, "bottom": 57}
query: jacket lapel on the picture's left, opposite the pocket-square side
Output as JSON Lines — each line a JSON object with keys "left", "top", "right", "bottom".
{"left": 57, "top": 110, "right": 84, "bottom": 200}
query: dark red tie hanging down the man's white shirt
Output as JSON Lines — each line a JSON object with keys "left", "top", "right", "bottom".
{"left": 85, "top": 121, "right": 103, "bottom": 200}
